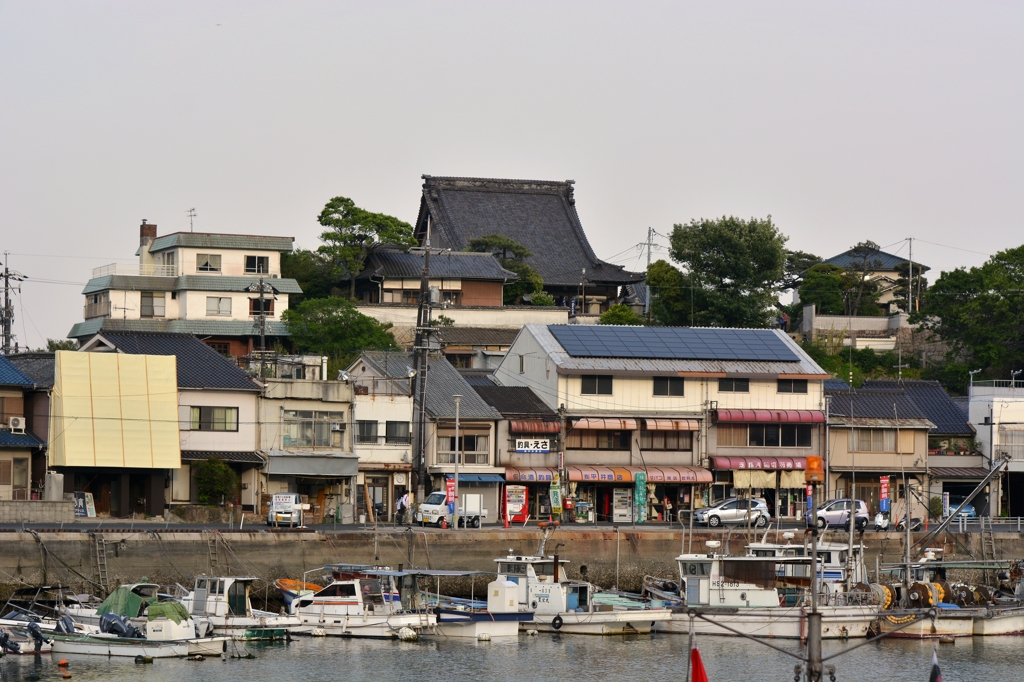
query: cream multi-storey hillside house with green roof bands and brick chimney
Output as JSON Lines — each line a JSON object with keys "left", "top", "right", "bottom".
{"left": 68, "top": 221, "right": 302, "bottom": 356}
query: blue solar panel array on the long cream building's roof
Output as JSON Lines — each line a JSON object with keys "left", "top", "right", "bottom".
{"left": 548, "top": 325, "right": 800, "bottom": 363}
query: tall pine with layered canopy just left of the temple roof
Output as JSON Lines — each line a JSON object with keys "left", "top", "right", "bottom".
{"left": 316, "top": 192, "right": 417, "bottom": 299}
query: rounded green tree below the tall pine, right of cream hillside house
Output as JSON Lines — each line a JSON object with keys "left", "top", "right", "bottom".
{"left": 282, "top": 297, "right": 398, "bottom": 367}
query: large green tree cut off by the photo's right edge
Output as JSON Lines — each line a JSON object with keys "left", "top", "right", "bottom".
{"left": 910, "top": 246, "right": 1024, "bottom": 379}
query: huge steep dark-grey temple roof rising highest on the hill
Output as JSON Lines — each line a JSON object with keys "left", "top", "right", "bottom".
{"left": 416, "top": 175, "right": 644, "bottom": 287}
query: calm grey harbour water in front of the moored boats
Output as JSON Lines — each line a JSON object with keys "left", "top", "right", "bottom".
{"left": 9, "top": 635, "right": 1024, "bottom": 682}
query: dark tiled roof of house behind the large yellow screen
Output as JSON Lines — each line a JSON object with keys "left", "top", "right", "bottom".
{"left": 91, "top": 332, "right": 259, "bottom": 392}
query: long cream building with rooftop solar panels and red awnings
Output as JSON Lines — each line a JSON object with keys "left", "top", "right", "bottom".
{"left": 495, "top": 325, "right": 827, "bottom": 521}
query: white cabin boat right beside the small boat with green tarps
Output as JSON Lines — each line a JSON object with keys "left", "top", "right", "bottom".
{"left": 177, "top": 576, "right": 302, "bottom": 641}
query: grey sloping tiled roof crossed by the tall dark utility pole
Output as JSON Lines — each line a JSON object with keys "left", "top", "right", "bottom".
{"left": 360, "top": 351, "right": 502, "bottom": 421}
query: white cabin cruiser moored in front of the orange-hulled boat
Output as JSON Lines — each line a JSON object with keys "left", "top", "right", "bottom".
{"left": 292, "top": 564, "right": 437, "bottom": 639}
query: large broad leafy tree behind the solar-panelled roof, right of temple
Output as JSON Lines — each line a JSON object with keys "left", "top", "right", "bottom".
{"left": 670, "top": 216, "right": 786, "bottom": 327}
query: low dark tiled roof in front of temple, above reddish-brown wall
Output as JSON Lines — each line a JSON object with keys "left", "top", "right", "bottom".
{"left": 359, "top": 250, "right": 519, "bottom": 282}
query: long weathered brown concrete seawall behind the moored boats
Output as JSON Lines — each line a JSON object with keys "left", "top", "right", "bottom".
{"left": 0, "top": 527, "right": 1024, "bottom": 594}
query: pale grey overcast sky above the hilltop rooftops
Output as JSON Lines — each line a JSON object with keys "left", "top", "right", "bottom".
{"left": 0, "top": 0, "right": 1024, "bottom": 347}
